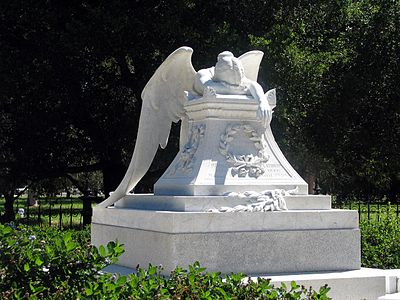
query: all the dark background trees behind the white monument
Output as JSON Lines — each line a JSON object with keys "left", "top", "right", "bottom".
{"left": 0, "top": 0, "right": 400, "bottom": 220}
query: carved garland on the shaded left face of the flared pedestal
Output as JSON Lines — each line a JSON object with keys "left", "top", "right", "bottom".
{"left": 169, "top": 124, "right": 206, "bottom": 175}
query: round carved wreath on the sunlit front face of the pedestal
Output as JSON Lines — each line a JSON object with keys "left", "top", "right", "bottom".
{"left": 219, "top": 124, "right": 269, "bottom": 178}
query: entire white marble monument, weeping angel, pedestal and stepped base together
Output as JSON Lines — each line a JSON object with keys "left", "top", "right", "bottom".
{"left": 92, "top": 47, "right": 360, "bottom": 274}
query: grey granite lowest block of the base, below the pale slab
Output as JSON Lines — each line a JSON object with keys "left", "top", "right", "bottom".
{"left": 92, "top": 224, "right": 360, "bottom": 274}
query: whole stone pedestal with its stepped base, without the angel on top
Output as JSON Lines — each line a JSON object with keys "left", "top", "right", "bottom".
{"left": 92, "top": 95, "right": 360, "bottom": 275}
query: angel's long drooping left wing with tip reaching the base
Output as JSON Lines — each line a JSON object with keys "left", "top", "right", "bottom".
{"left": 99, "top": 47, "right": 196, "bottom": 207}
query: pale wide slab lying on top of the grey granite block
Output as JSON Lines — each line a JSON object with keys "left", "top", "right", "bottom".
{"left": 92, "top": 207, "right": 358, "bottom": 233}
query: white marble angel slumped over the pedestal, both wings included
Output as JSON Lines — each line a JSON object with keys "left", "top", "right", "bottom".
{"left": 99, "top": 47, "right": 275, "bottom": 207}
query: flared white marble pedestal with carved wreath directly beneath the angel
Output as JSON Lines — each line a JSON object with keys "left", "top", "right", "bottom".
{"left": 154, "top": 95, "right": 308, "bottom": 196}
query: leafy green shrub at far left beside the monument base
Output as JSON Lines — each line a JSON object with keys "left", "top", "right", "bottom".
{"left": 0, "top": 225, "right": 123, "bottom": 299}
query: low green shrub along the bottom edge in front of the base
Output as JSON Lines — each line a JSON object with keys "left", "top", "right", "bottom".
{"left": 86, "top": 262, "right": 330, "bottom": 300}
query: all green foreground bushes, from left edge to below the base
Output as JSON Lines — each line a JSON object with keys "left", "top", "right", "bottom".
{"left": 0, "top": 225, "right": 329, "bottom": 299}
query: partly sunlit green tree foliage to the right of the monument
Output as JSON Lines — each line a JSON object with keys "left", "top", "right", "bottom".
{"left": 250, "top": 0, "right": 400, "bottom": 197}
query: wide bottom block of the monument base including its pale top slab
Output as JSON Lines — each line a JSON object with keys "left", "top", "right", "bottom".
{"left": 92, "top": 196, "right": 361, "bottom": 275}
